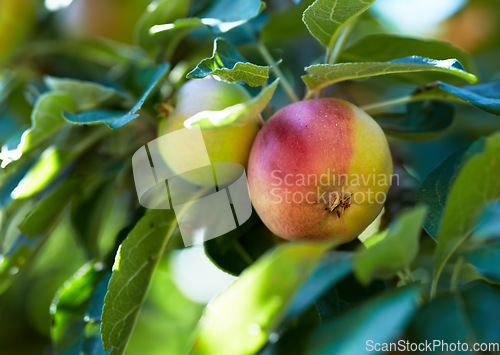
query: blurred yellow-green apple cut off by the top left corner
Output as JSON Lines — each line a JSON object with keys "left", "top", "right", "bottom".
{"left": 0, "top": 0, "right": 39, "bottom": 63}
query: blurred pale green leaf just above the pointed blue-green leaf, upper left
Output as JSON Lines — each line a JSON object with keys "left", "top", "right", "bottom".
{"left": 44, "top": 76, "right": 123, "bottom": 111}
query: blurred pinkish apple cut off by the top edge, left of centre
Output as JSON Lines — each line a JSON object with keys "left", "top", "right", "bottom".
{"left": 60, "top": 0, "right": 150, "bottom": 43}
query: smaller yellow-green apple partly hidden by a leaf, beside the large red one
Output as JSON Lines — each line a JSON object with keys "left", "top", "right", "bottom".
{"left": 158, "top": 78, "right": 260, "bottom": 185}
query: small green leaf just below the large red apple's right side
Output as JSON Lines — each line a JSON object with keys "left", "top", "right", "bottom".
{"left": 354, "top": 207, "right": 427, "bottom": 284}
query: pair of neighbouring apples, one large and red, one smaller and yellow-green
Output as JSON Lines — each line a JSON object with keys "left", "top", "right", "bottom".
{"left": 159, "top": 78, "right": 392, "bottom": 243}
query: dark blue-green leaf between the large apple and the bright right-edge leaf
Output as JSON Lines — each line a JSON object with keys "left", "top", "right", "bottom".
{"left": 417, "top": 138, "right": 485, "bottom": 240}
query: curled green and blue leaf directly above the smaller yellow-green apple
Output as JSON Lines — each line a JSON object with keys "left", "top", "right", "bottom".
{"left": 186, "top": 38, "right": 269, "bottom": 86}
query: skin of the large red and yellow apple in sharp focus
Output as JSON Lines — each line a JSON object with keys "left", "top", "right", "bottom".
{"left": 248, "top": 98, "right": 392, "bottom": 243}
